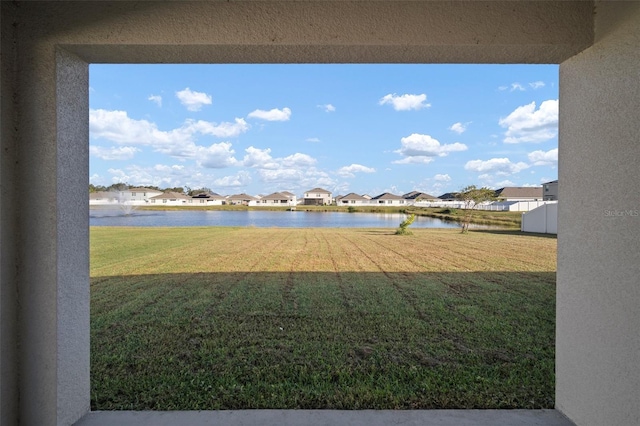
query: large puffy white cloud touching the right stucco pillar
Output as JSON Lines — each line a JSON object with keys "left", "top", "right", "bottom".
{"left": 498, "top": 99, "right": 558, "bottom": 143}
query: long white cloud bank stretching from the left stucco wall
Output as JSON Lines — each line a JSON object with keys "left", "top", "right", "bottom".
{"left": 89, "top": 109, "right": 249, "bottom": 167}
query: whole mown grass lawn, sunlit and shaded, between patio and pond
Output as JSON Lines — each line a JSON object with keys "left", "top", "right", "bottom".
{"left": 91, "top": 227, "right": 556, "bottom": 410}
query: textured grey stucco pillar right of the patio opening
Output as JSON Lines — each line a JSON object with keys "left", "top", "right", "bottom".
{"left": 556, "top": 2, "right": 640, "bottom": 426}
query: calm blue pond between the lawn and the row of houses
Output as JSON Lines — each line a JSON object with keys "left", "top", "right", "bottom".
{"left": 89, "top": 209, "right": 460, "bottom": 228}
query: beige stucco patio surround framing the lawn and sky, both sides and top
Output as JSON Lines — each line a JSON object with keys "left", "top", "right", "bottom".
{"left": 0, "top": 1, "right": 640, "bottom": 426}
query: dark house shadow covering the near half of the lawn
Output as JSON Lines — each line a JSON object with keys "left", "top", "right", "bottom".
{"left": 91, "top": 272, "right": 555, "bottom": 410}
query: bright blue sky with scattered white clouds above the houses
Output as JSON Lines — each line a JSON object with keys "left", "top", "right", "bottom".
{"left": 89, "top": 64, "right": 558, "bottom": 196}
